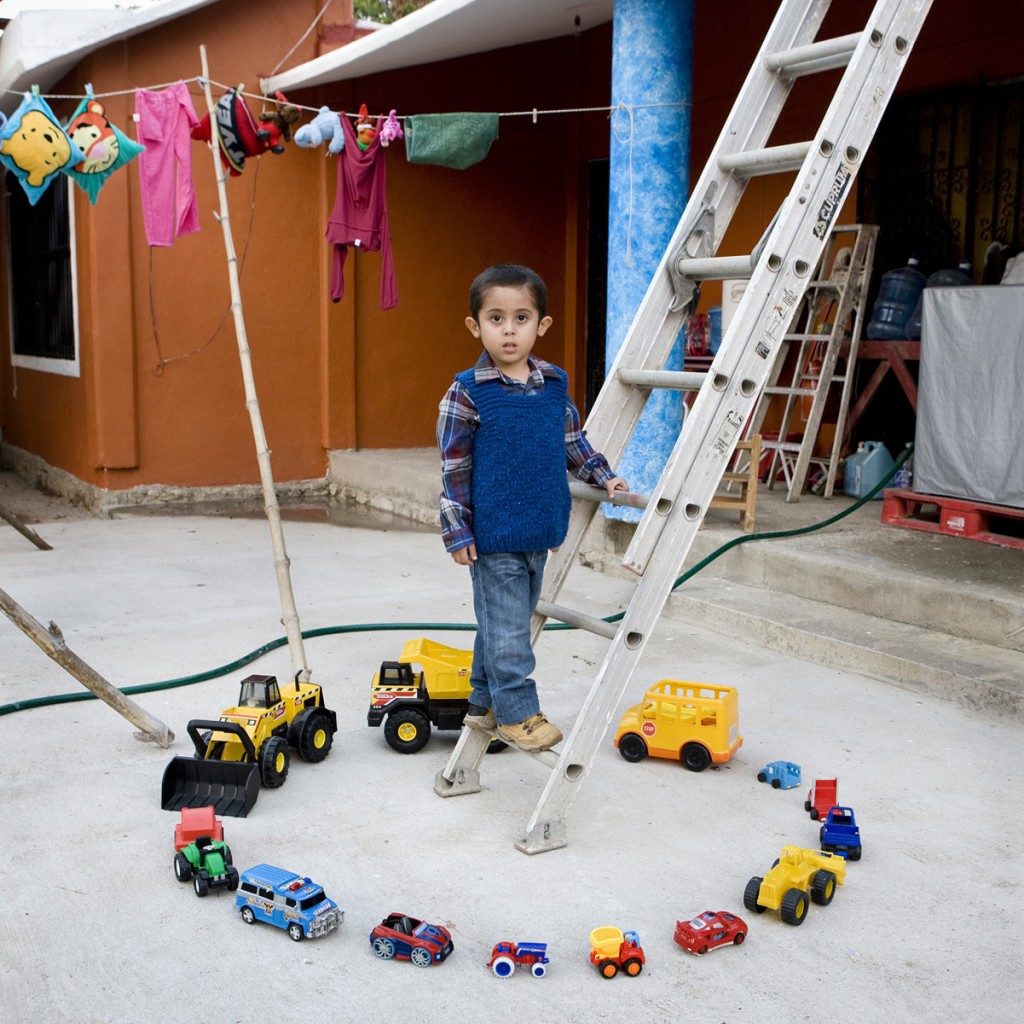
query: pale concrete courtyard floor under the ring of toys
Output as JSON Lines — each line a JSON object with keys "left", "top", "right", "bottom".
{"left": 0, "top": 499, "right": 1024, "bottom": 1024}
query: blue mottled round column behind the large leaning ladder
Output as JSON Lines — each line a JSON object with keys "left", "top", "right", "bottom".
{"left": 602, "top": 0, "right": 693, "bottom": 522}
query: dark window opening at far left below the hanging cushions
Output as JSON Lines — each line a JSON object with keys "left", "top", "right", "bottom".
{"left": 6, "top": 173, "right": 75, "bottom": 359}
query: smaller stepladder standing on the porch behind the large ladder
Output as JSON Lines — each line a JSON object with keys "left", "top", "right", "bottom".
{"left": 737, "top": 224, "right": 879, "bottom": 502}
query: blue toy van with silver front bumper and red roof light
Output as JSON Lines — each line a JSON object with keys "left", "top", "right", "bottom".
{"left": 234, "top": 864, "right": 345, "bottom": 942}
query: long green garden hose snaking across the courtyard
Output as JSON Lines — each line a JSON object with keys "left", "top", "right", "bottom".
{"left": 0, "top": 444, "right": 913, "bottom": 716}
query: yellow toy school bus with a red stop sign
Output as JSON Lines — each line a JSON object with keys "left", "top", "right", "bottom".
{"left": 614, "top": 679, "right": 743, "bottom": 771}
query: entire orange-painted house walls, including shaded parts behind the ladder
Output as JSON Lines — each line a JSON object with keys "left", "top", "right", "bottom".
{"left": 0, "top": 0, "right": 1024, "bottom": 488}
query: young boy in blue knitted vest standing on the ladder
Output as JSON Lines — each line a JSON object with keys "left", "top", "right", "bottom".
{"left": 437, "top": 263, "right": 628, "bottom": 751}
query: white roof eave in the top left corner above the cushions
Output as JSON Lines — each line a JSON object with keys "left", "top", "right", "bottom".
{"left": 0, "top": 0, "right": 218, "bottom": 114}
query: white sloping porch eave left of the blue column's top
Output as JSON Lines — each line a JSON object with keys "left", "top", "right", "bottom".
{"left": 262, "top": 0, "right": 612, "bottom": 93}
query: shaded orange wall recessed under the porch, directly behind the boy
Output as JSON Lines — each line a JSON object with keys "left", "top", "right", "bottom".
{"left": 296, "top": 27, "right": 610, "bottom": 447}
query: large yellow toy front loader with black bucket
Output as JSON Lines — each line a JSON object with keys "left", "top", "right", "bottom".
{"left": 161, "top": 676, "right": 338, "bottom": 818}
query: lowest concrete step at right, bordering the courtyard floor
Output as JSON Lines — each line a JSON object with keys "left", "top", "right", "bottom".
{"left": 665, "top": 577, "right": 1024, "bottom": 717}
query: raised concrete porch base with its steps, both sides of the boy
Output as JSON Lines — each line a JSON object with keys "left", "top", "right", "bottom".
{"left": 330, "top": 449, "right": 1024, "bottom": 716}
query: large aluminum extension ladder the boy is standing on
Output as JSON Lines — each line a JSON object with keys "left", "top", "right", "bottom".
{"left": 434, "top": 0, "right": 931, "bottom": 853}
